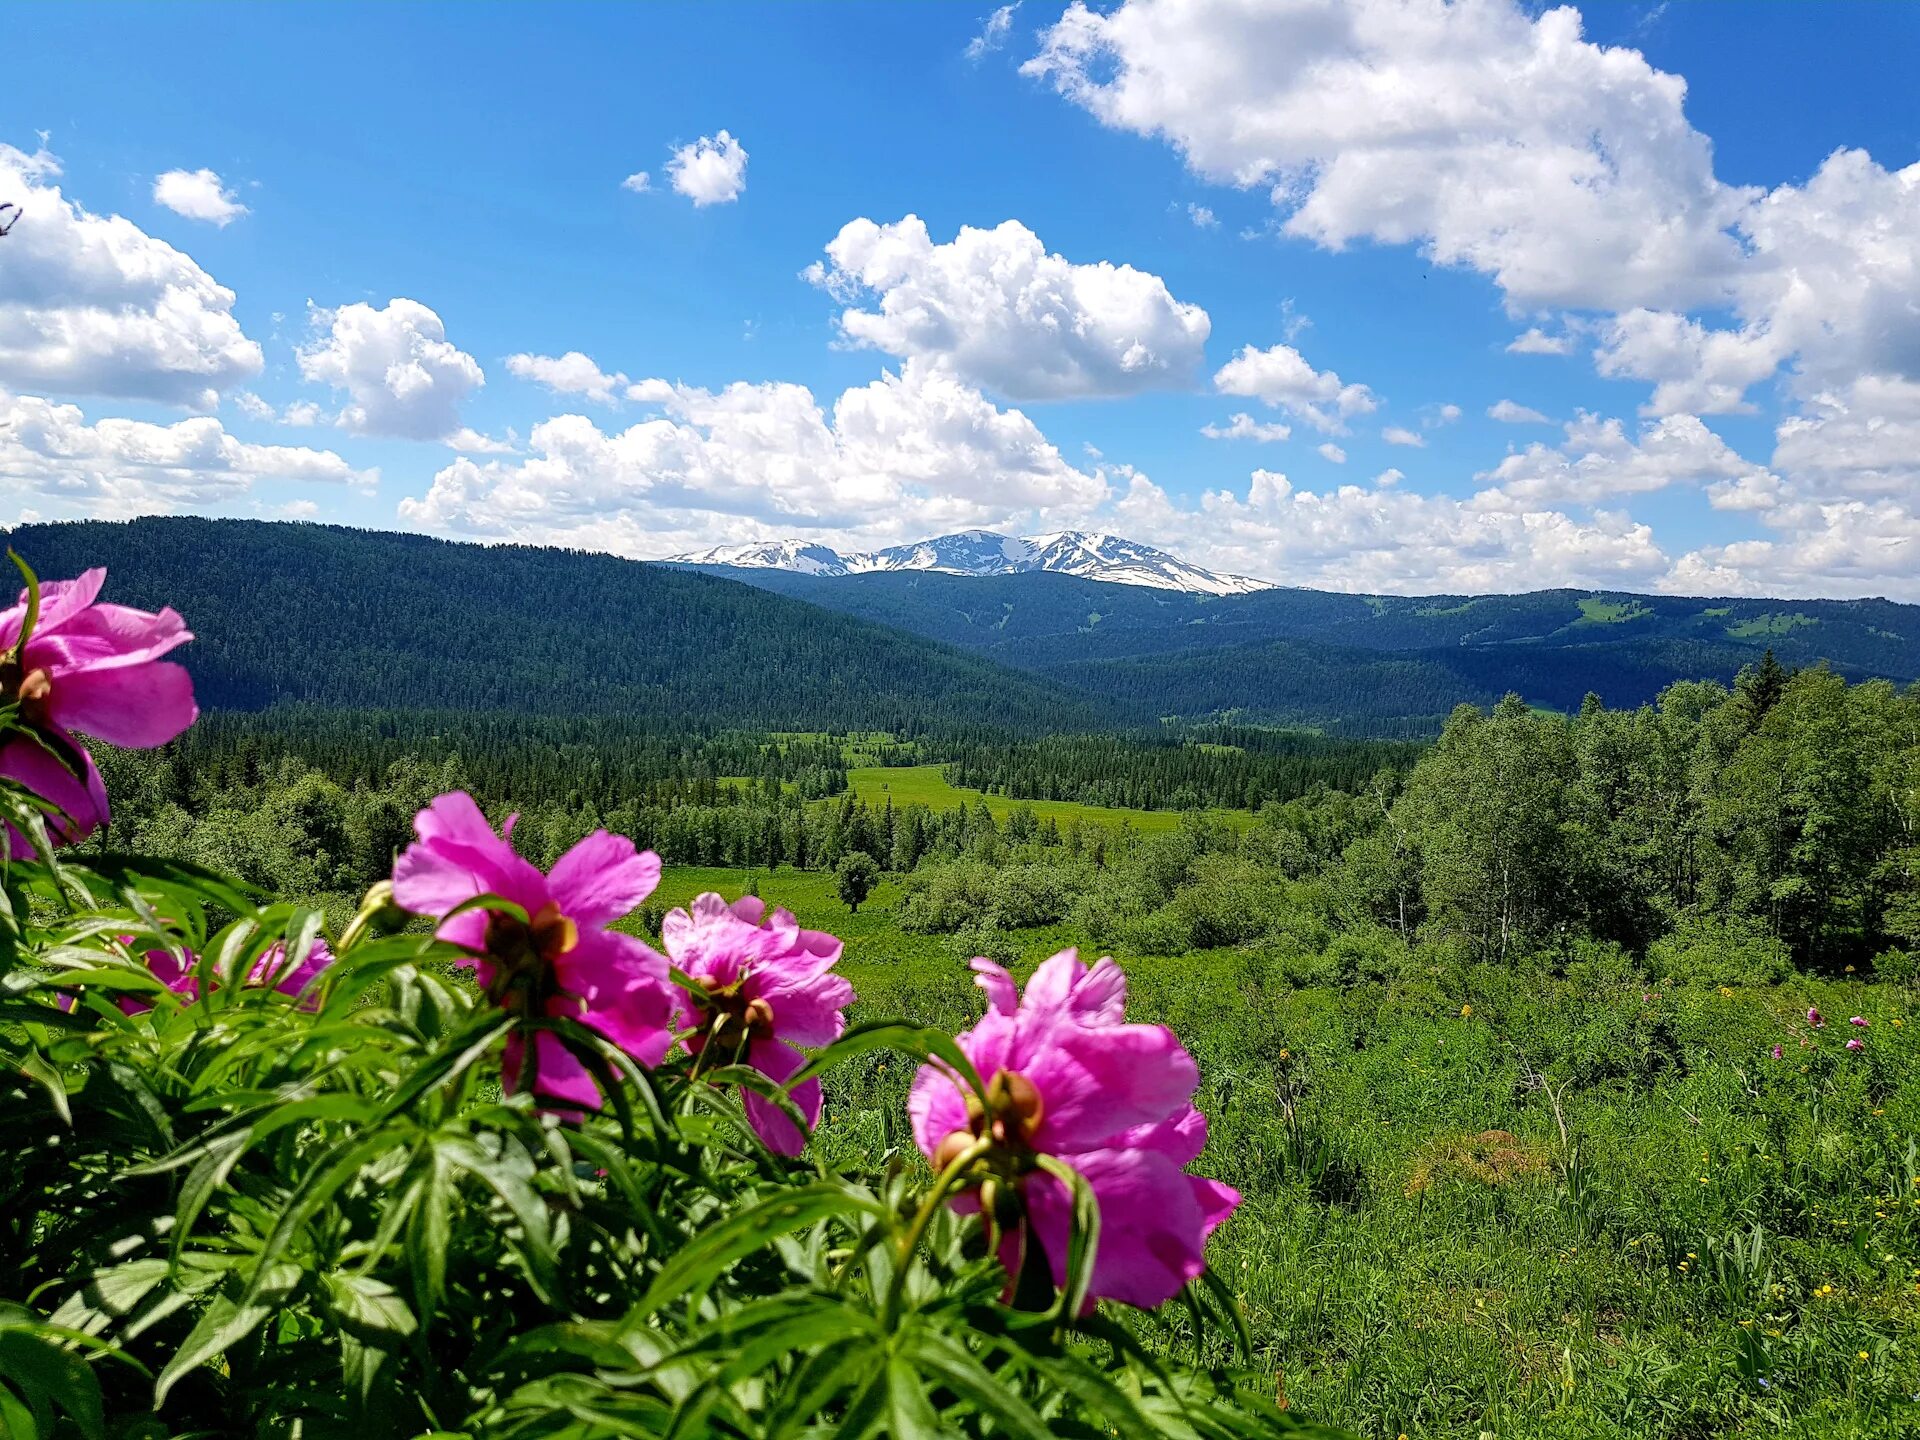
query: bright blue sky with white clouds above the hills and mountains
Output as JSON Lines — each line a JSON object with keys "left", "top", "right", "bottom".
{"left": 0, "top": 0, "right": 1920, "bottom": 599}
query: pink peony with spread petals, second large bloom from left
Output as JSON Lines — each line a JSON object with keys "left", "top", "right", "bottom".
{"left": 394, "top": 791, "right": 674, "bottom": 1108}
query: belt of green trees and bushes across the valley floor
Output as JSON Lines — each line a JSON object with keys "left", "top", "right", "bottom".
{"left": 90, "top": 659, "right": 1920, "bottom": 979}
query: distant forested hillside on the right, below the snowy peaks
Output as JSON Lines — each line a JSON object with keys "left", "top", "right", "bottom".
{"left": 716, "top": 570, "right": 1920, "bottom": 735}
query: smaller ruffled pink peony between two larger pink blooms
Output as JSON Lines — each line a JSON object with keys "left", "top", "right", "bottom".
{"left": 660, "top": 893, "right": 854, "bottom": 1156}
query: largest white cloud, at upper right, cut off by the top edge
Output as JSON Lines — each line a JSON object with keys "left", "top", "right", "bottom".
{"left": 1023, "top": 0, "right": 1751, "bottom": 309}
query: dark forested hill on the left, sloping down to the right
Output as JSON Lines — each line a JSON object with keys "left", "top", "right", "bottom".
{"left": 10, "top": 516, "right": 1112, "bottom": 733}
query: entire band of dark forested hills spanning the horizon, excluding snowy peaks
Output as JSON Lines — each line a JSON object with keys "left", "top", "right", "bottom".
{"left": 8, "top": 516, "right": 1920, "bottom": 737}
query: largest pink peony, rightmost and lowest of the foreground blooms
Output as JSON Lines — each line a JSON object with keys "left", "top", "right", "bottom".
{"left": 906, "top": 950, "right": 1240, "bottom": 1308}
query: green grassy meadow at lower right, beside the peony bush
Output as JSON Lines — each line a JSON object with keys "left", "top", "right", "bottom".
{"left": 625, "top": 867, "right": 1920, "bottom": 1440}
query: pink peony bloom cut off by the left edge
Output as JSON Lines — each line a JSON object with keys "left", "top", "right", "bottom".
{"left": 0, "top": 570, "right": 200, "bottom": 858}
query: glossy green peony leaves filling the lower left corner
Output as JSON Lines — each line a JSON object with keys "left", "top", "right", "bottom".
{"left": 0, "top": 844, "right": 1304, "bottom": 1440}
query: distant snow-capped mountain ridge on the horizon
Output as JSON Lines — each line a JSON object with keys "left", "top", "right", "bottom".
{"left": 674, "top": 530, "right": 1273, "bottom": 595}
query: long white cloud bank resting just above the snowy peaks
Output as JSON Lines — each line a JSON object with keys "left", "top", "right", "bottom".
{"left": 399, "top": 361, "right": 1106, "bottom": 555}
